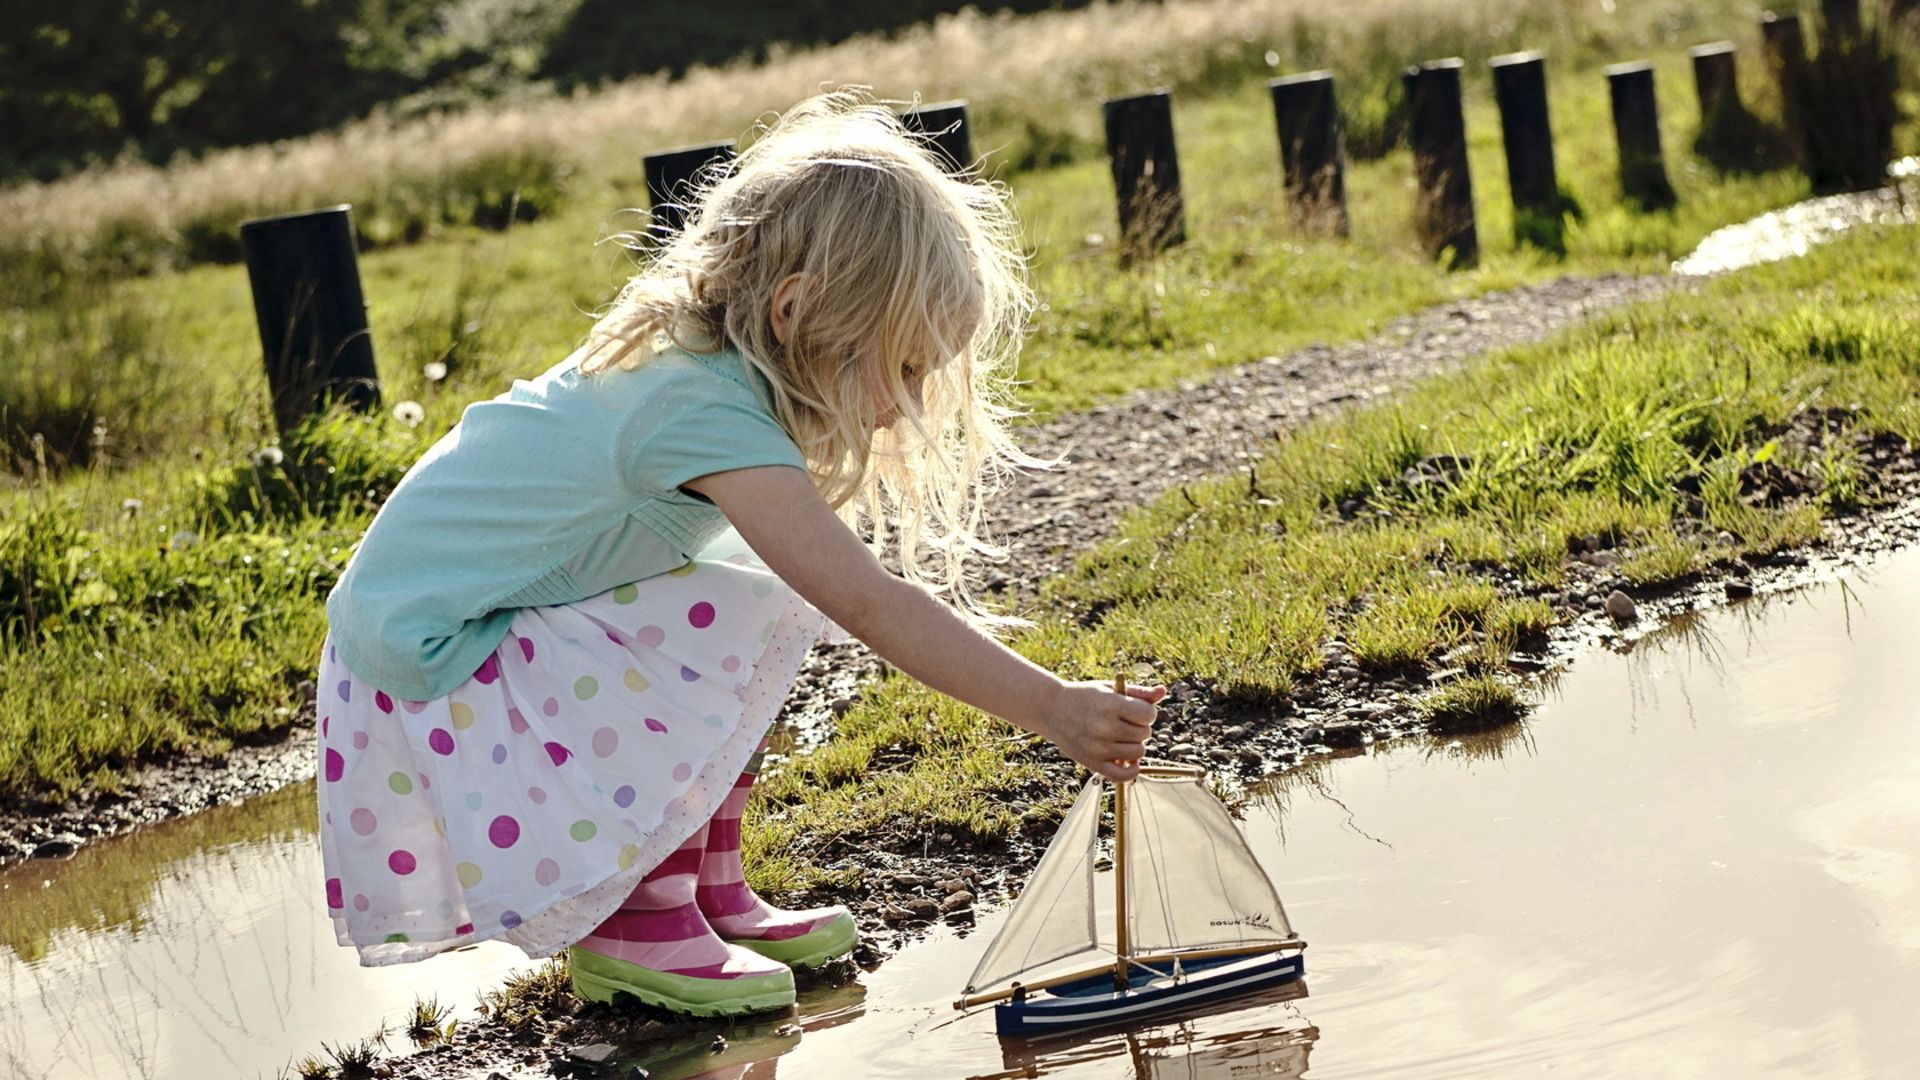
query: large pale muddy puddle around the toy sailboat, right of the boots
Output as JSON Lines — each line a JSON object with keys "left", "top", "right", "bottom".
{"left": 634, "top": 552, "right": 1920, "bottom": 1080}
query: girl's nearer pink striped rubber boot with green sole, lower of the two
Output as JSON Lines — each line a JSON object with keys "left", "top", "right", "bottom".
{"left": 566, "top": 826, "right": 793, "bottom": 1017}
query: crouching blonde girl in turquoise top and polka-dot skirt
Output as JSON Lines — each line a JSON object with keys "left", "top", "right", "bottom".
{"left": 319, "top": 92, "right": 1164, "bottom": 1015}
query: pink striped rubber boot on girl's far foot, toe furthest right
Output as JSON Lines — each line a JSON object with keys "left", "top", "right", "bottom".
{"left": 697, "top": 742, "right": 858, "bottom": 967}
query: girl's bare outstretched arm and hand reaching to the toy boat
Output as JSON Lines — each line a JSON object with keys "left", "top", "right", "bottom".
{"left": 685, "top": 465, "right": 1165, "bottom": 780}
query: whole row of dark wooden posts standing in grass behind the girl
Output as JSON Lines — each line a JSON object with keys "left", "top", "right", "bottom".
{"left": 240, "top": 0, "right": 1859, "bottom": 434}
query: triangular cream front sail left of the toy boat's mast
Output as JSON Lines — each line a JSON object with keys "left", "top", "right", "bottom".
{"left": 966, "top": 776, "right": 1110, "bottom": 994}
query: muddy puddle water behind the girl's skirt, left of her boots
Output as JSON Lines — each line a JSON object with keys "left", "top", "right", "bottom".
{"left": 0, "top": 782, "right": 530, "bottom": 1080}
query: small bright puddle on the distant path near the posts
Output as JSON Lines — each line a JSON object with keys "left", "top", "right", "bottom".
{"left": 1672, "top": 158, "right": 1920, "bottom": 275}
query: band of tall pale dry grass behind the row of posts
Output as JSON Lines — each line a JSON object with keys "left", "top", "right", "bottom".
{"left": 0, "top": 0, "right": 1757, "bottom": 271}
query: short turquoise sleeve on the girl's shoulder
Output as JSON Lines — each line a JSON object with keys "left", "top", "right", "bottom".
{"left": 628, "top": 400, "right": 806, "bottom": 494}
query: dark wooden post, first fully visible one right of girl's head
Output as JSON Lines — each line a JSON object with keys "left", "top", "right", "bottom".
{"left": 1100, "top": 90, "right": 1187, "bottom": 259}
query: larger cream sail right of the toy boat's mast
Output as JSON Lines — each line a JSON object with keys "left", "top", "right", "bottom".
{"left": 1121, "top": 773, "right": 1294, "bottom": 955}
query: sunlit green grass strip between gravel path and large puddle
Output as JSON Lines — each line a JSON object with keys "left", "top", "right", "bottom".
{"left": 747, "top": 229, "right": 1920, "bottom": 890}
